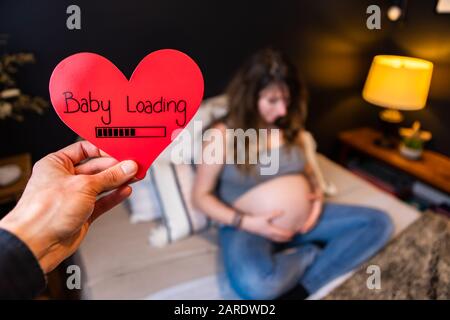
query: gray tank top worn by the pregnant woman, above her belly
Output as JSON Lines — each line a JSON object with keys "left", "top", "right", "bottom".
{"left": 217, "top": 145, "right": 305, "bottom": 205}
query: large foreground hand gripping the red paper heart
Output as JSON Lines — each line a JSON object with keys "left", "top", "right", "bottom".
{"left": 0, "top": 141, "right": 137, "bottom": 273}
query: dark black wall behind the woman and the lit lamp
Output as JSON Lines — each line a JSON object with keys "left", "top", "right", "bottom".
{"left": 0, "top": 0, "right": 450, "bottom": 160}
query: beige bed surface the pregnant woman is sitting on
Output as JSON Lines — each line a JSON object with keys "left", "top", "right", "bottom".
{"left": 78, "top": 154, "right": 420, "bottom": 299}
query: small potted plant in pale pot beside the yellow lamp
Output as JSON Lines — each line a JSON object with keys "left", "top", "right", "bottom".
{"left": 399, "top": 121, "right": 431, "bottom": 160}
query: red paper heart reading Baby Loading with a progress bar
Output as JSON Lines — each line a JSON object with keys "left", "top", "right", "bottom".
{"left": 49, "top": 49, "right": 203, "bottom": 178}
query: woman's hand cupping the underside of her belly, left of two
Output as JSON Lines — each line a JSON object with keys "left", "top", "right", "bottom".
{"left": 241, "top": 210, "right": 295, "bottom": 242}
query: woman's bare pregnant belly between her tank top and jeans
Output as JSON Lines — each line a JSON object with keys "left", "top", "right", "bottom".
{"left": 233, "top": 174, "right": 311, "bottom": 231}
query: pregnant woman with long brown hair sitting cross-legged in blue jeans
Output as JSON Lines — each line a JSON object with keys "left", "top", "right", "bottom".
{"left": 193, "top": 49, "right": 393, "bottom": 299}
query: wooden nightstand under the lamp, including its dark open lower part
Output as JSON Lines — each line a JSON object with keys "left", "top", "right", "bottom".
{"left": 338, "top": 128, "right": 450, "bottom": 216}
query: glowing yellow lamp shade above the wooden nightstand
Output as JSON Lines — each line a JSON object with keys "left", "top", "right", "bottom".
{"left": 363, "top": 55, "right": 433, "bottom": 110}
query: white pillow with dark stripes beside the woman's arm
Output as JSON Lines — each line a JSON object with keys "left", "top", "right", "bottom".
{"left": 145, "top": 95, "right": 227, "bottom": 246}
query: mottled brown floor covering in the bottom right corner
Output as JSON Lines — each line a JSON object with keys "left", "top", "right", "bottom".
{"left": 326, "top": 212, "right": 450, "bottom": 300}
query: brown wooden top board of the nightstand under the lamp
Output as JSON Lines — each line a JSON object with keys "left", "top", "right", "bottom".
{"left": 339, "top": 128, "right": 450, "bottom": 194}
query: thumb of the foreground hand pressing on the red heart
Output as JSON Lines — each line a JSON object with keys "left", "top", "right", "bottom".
{"left": 93, "top": 160, "right": 138, "bottom": 193}
